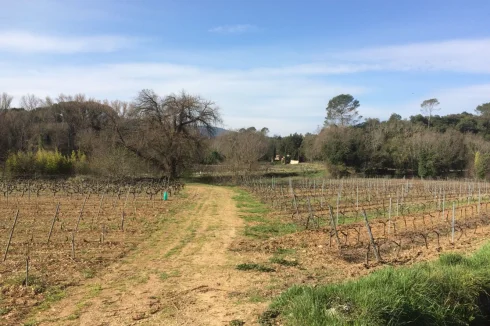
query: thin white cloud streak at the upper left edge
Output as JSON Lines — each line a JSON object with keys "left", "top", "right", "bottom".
{"left": 0, "top": 31, "right": 134, "bottom": 54}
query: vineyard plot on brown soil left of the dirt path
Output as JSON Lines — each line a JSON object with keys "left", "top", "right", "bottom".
{"left": 0, "top": 179, "right": 183, "bottom": 321}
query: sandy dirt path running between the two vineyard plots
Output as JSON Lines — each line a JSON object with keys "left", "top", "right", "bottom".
{"left": 35, "top": 185, "right": 266, "bottom": 325}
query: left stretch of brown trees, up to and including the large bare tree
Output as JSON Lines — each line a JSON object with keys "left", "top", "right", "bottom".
{"left": 0, "top": 89, "right": 221, "bottom": 178}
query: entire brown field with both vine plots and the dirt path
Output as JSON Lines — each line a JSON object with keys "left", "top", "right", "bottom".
{"left": 0, "top": 177, "right": 490, "bottom": 325}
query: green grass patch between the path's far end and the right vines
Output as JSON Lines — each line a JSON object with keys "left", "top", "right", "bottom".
{"left": 233, "top": 188, "right": 298, "bottom": 240}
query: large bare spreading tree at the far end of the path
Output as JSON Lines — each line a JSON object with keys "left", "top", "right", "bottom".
{"left": 115, "top": 89, "right": 221, "bottom": 178}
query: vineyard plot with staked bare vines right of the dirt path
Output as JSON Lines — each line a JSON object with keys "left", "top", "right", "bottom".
{"left": 246, "top": 179, "right": 490, "bottom": 265}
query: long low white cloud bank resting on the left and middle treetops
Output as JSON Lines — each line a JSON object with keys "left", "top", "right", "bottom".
{"left": 0, "top": 63, "right": 369, "bottom": 134}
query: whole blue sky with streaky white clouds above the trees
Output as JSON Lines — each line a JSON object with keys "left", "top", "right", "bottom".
{"left": 0, "top": 0, "right": 490, "bottom": 135}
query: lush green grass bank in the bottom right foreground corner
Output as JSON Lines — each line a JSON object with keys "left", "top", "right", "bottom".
{"left": 266, "top": 245, "right": 490, "bottom": 326}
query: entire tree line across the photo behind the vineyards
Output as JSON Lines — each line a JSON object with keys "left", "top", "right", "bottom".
{"left": 0, "top": 89, "right": 490, "bottom": 178}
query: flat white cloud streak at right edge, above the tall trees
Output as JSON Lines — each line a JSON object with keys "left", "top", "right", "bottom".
{"left": 340, "top": 38, "right": 490, "bottom": 74}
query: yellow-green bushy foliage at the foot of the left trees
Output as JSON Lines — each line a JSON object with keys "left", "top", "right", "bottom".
{"left": 7, "top": 149, "right": 87, "bottom": 175}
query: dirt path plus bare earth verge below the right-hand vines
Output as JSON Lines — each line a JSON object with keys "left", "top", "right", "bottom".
{"left": 16, "top": 184, "right": 490, "bottom": 325}
